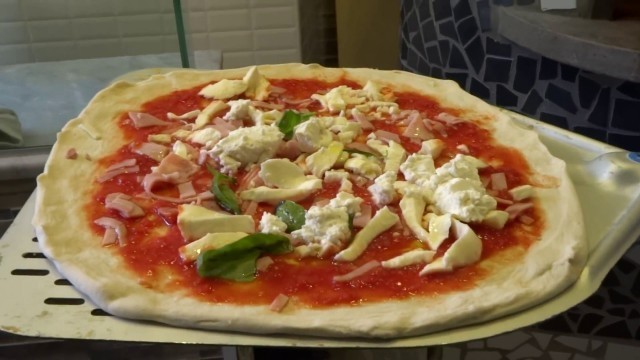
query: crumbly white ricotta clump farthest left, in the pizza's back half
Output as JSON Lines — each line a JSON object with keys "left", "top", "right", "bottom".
{"left": 210, "top": 126, "right": 284, "bottom": 174}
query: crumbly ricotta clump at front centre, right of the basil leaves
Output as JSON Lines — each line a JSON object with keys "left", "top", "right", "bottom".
{"left": 291, "top": 206, "right": 351, "bottom": 254}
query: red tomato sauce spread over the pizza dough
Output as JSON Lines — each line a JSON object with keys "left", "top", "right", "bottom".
{"left": 86, "top": 76, "right": 544, "bottom": 307}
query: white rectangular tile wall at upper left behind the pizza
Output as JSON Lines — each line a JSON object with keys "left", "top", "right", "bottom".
{"left": 0, "top": 0, "right": 301, "bottom": 68}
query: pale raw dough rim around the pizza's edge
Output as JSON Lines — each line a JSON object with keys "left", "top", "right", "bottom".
{"left": 33, "top": 64, "right": 588, "bottom": 338}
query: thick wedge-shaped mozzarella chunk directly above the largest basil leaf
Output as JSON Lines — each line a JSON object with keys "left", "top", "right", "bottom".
{"left": 178, "top": 204, "right": 255, "bottom": 241}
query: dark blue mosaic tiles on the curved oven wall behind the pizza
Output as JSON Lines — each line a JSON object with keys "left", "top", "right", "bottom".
{"left": 401, "top": 0, "right": 640, "bottom": 151}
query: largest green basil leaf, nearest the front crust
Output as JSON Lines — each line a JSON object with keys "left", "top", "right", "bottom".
{"left": 196, "top": 233, "right": 292, "bottom": 282}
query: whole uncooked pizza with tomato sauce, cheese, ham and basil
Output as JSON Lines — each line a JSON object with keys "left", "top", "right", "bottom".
{"left": 33, "top": 64, "right": 587, "bottom": 338}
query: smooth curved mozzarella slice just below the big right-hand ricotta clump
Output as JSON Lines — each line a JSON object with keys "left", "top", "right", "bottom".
{"left": 420, "top": 220, "right": 482, "bottom": 276}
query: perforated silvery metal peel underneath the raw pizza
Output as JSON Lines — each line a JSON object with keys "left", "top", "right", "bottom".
{"left": 0, "top": 114, "right": 640, "bottom": 348}
